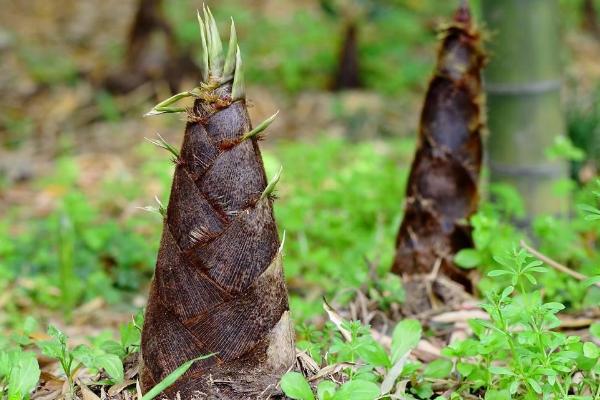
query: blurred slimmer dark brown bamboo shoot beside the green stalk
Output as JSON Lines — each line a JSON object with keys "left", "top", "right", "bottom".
{"left": 392, "top": 4, "right": 485, "bottom": 312}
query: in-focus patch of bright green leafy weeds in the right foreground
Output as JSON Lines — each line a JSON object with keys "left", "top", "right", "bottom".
{"left": 281, "top": 250, "right": 600, "bottom": 400}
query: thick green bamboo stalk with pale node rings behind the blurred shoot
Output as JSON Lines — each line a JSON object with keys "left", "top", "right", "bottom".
{"left": 482, "top": 0, "right": 567, "bottom": 216}
